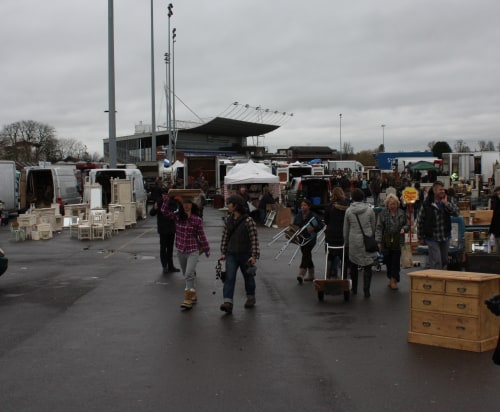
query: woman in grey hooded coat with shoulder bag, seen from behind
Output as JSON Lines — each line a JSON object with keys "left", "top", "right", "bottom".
{"left": 344, "top": 188, "right": 377, "bottom": 298}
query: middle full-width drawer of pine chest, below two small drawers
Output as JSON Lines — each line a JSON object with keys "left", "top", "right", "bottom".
{"left": 411, "top": 292, "right": 479, "bottom": 316}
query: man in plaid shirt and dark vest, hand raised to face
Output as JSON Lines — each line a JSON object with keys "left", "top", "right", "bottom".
{"left": 417, "top": 181, "right": 459, "bottom": 269}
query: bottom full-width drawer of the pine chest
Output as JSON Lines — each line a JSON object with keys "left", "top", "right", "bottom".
{"left": 411, "top": 311, "right": 480, "bottom": 345}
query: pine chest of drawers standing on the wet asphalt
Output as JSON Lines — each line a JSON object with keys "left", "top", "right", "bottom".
{"left": 408, "top": 269, "right": 500, "bottom": 352}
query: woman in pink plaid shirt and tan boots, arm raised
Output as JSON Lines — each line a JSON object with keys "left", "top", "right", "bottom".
{"left": 161, "top": 198, "right": 210, "bottom": 309}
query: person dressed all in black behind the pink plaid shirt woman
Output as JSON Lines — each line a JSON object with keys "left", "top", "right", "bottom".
{"left": 149, "top": 189, "right": 179, "bottom": 274}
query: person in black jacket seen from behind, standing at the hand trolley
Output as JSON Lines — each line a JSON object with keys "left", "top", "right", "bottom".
{"left": 325, "top": 186, "right": 349, "bottom": 278}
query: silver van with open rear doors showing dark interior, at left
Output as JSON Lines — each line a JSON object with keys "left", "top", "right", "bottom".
{"left": 19, "top": 165, "right": 82, "bottom": 211}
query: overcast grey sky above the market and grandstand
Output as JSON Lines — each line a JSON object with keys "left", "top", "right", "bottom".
{"left": 0, "top": 0, "right": 500, "bottom": 153}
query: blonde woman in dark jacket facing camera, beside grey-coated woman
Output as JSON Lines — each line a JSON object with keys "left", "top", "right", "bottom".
{"left": 375, "top": 194, "right": 410, "bottom": 290}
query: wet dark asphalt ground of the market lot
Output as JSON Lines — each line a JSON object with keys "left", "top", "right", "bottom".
{"left": 0, "top": 207, "right": 500, "bottom": 411}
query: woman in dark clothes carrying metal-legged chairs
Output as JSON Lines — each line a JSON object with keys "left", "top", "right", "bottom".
{"left": 293, "top": 199, "right": 324, "bottom": 284}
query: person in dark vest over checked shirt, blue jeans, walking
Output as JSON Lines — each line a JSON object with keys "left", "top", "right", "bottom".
{"left": 220, "top": 195, "right": 260, "bottom": 314}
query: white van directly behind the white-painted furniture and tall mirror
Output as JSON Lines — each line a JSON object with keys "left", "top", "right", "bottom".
{"left": 84, "top": 169, "right": 147, "bottom": 219}
